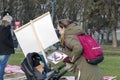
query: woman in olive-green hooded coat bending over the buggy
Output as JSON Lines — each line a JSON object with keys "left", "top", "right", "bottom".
{"left": 58, "top": 19, "right": 103, "bottom": 80}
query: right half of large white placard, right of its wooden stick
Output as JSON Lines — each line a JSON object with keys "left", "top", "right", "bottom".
{"left": 34, "top": 15, "right": 59, "bottom": 49}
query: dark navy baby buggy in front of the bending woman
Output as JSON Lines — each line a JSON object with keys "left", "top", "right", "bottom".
{"left": 21, "top": 52, "right": 67, "bottom": 80}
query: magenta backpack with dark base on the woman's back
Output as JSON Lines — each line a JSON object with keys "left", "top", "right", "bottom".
{"left": 77, "top": 34, "right": 104, "bottom": 65}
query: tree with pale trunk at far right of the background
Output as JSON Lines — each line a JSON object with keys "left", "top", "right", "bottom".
{"left": 85, "top": 0, "right": 118, "bottom": 47}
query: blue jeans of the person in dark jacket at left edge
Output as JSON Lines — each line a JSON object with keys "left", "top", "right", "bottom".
{"left": 0, "top": 55, "right": 10, "bottom": 80}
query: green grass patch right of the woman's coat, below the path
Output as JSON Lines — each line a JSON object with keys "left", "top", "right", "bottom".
{"left": 99, "top": 56, "right": 120, "bottom": 80}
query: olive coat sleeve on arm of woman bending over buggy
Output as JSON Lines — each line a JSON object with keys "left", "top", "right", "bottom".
{"left": 65, "top": 35, "right": 83, "bottom": 63}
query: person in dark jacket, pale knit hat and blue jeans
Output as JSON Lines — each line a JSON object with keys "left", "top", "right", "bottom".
{"left": 0, "top": 14, "right": 14, "bottom": 80}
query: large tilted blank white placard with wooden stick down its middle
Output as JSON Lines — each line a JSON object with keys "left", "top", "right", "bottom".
{"left": 14, "top": 12, "right": 59, "bottom": 62}
